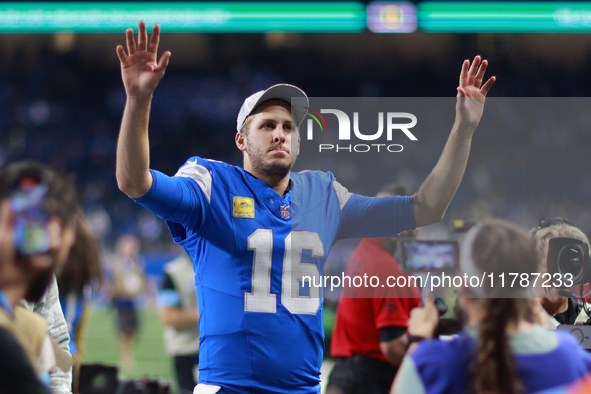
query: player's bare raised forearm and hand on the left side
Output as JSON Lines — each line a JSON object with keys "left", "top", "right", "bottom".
{"left": 116, "top": 21, "right": 170, "bottom": 198}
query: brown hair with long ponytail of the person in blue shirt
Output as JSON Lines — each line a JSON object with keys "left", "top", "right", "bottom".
{"left": 466, "top": 220, "right": 537, "bottom": 394}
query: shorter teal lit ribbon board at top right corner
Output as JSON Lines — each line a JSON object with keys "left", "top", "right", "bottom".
{"left": 417, "top": 1, "right": 591, "bottom": 33}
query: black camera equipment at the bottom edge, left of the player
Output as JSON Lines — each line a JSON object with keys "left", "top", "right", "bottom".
{"left": 78, "top": 364, "right": 170, "bottom": 394}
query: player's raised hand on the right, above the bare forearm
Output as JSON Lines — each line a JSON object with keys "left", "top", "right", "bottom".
{"left": 456, "top": 55, "right": 497, "bottom": 133}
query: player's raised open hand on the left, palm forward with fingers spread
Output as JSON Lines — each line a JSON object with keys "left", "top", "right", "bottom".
{"left": 117, "top": 21, "right": 170, "bottom": 98}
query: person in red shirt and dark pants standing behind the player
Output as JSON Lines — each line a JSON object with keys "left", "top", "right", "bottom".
{"left": 327, "top": 184, "right": 421, "bottom": 394}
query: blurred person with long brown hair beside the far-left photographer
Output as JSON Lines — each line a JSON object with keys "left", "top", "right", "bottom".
{"left": 57, "top": 211, "right": 103, "bottom": 391}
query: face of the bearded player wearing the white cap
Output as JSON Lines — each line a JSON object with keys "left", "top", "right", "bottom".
{"left": 236, "top": 100, "right": 300, "bottom": 177}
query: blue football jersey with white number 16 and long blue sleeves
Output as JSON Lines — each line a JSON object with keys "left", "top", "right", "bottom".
{"left": 136, "top": 157, "right": 415, "bottom": 393}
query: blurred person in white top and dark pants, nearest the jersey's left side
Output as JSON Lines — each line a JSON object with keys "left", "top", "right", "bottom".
{"left": 158, "top": 253, "right": 199, "bottom": 394}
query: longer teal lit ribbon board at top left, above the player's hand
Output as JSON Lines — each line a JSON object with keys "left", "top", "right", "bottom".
{"left": 0, "top": 2, "right": 366, "bottom": 33}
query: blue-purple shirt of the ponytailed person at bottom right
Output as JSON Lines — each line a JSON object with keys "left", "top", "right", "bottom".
{"left": 396, "top": 326, "right": 591, "bottom": 394}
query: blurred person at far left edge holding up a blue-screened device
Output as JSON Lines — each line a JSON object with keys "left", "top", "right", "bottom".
{"left": 0, "top": 163, "right": 77, "bottom": 394}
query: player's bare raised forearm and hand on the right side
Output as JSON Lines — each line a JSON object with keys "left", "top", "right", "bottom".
{"left": 413, "top": 56, "right": 496, "bottom": 227}
